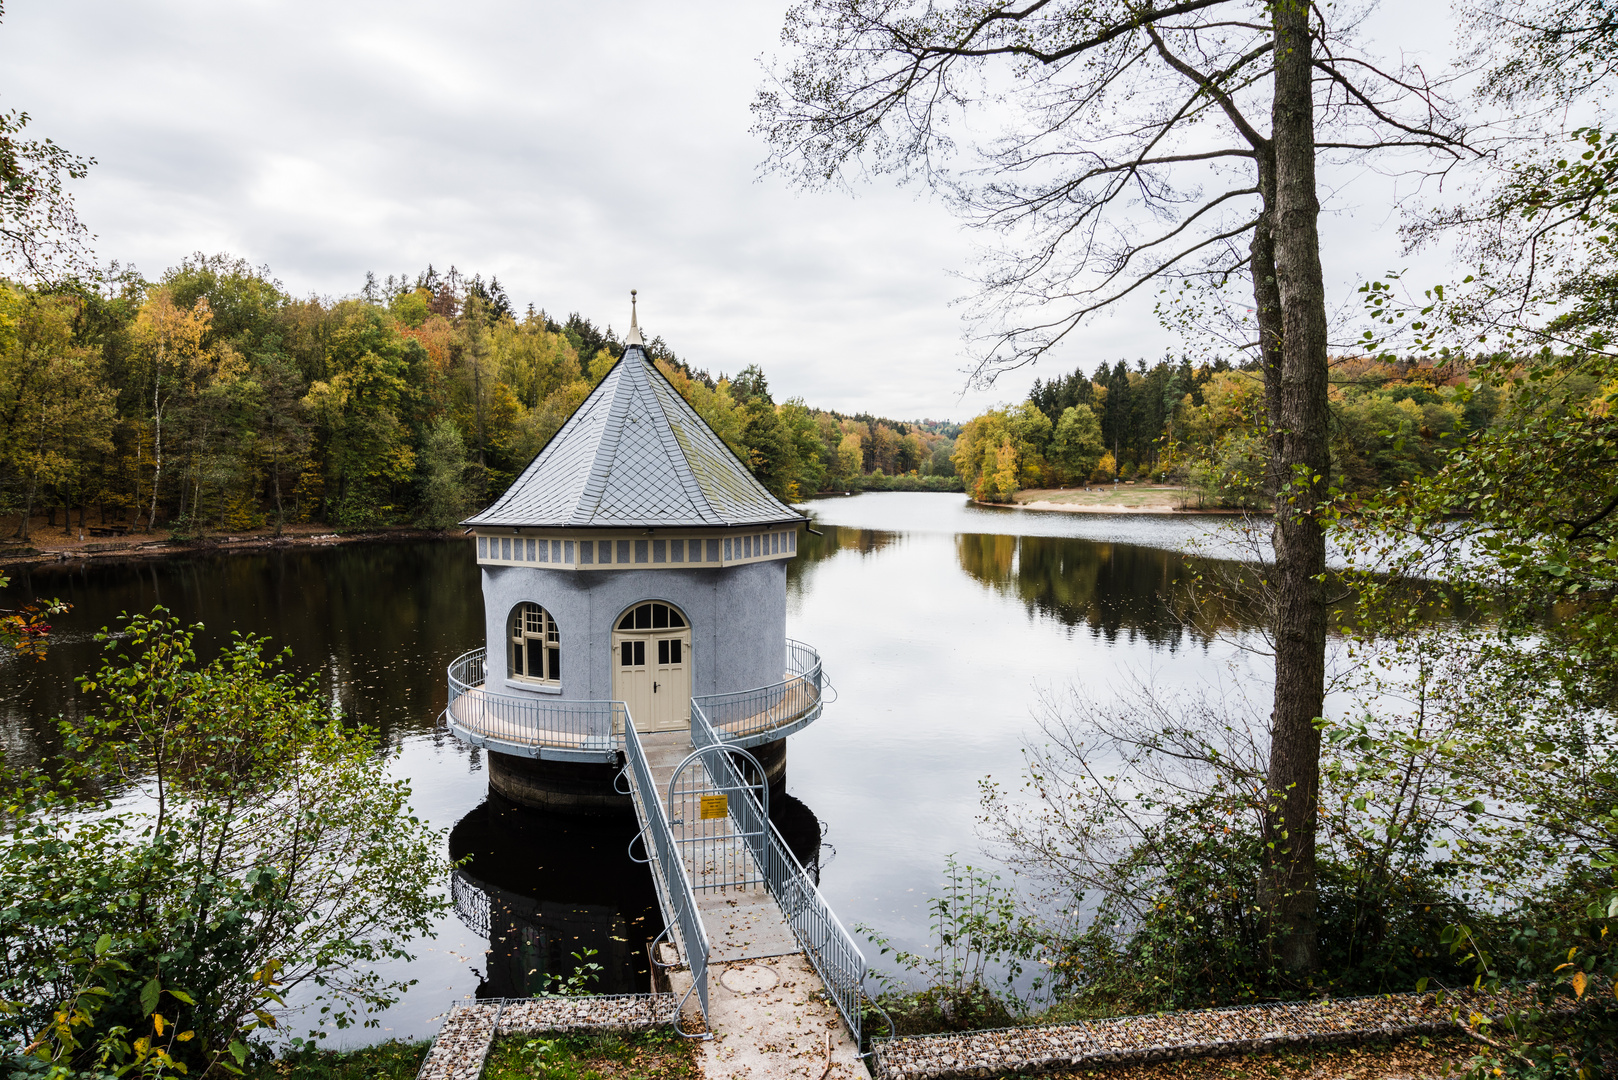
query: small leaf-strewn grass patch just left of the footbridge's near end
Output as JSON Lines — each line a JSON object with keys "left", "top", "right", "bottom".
{"left": 484, "top": 1028, "right": 701, "bottom": 1080}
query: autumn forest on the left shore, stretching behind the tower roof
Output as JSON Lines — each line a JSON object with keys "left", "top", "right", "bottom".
{"left": 0, "top": 254, "right": 959, "bottom": 539}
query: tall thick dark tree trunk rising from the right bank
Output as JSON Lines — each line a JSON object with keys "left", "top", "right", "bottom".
{"left": 1265, "top": 0, "right": 1330, "bottom": 976}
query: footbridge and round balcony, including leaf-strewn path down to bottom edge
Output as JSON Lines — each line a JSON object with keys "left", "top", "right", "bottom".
{"left": 443, "top": 641, "right": 866, "bottom": 1080}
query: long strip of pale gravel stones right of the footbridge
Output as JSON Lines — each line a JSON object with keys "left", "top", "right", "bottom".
{"left": 874, "top": 994, "right": 1540, "bottom": 1080}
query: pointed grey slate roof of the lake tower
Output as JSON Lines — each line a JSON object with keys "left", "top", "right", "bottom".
{"left": 461, "top": 345, "right": 804, "bottom": 528}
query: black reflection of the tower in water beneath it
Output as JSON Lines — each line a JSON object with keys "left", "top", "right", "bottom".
{"left": 450, "top": 792, "right": 830, "bottom": 997}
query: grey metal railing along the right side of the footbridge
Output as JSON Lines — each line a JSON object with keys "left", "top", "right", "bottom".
{"left": 691, "top": 702, "right": 866, "bottom": 1046}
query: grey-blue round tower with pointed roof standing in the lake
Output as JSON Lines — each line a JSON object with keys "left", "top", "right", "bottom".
{"left": 445, "top": 296, "right": 820, "bottom": 813}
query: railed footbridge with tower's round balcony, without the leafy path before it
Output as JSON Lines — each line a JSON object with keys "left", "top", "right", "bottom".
{"left": 443, "top": 641, "right": 866, "bottom": 1049}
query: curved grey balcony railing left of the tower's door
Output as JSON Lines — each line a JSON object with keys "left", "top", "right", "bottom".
{"left": 443, "top": 649, "right": 628, "bottom": 763}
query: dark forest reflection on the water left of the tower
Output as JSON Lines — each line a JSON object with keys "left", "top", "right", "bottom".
{"left": 0, "top": 542, "right": 484, "bottom": 764}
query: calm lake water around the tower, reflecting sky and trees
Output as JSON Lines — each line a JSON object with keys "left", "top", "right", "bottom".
{"left": 0, "top": 492, "right": 1269, "bottom": 1044}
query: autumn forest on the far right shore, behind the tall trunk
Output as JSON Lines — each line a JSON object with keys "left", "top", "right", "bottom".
{"left": 955, "top": 355, "right": 1501, "bottom": 510}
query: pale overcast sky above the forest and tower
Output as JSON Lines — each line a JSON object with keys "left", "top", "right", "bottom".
{"left": 0, "top": 0, "right": 1469, "bottom": 419}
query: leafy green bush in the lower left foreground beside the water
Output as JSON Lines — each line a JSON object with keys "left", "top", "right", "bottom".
{"left": 0, "top": 609, "right": 447, "bottom": 1080}
